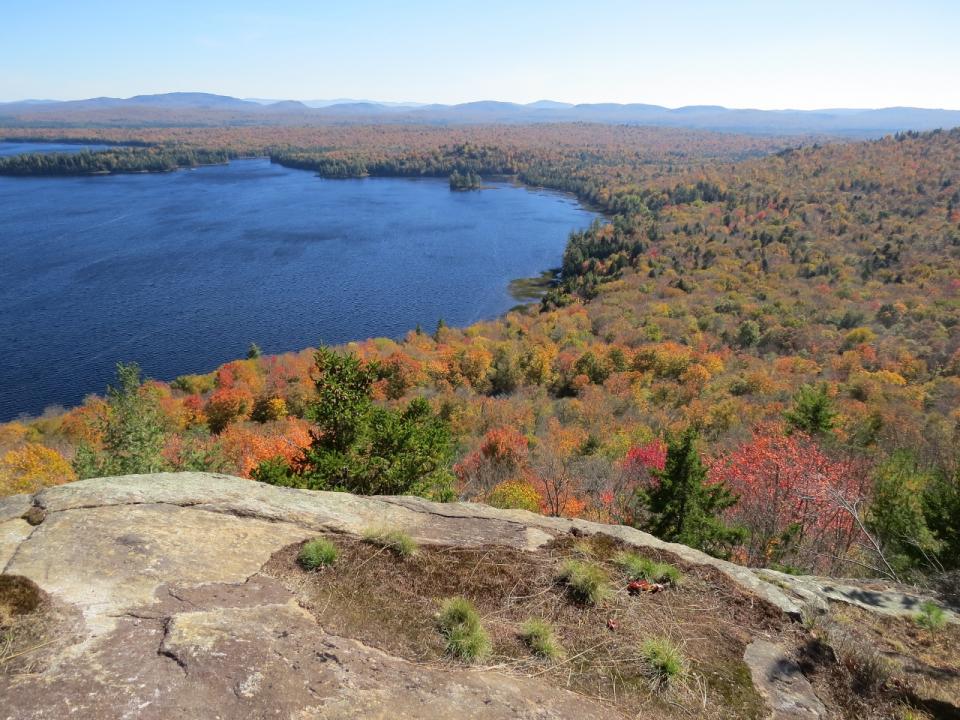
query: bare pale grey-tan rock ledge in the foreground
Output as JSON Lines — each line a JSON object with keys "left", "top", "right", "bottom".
{"left": 0, "top": 473, "right": 956, "bottom": 720}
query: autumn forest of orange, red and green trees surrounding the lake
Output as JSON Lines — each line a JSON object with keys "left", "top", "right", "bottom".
{"left": 0, "top": 124, "right": 960, "bottom": 593}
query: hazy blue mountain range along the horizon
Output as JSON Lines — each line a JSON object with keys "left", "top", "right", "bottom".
{"left": 0, "top": 92, "right": 960, "bottom": 137}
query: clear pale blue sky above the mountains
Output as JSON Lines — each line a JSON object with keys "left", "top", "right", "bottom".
{"left": 0, "top": 0, "right": 960, "bottom": 109}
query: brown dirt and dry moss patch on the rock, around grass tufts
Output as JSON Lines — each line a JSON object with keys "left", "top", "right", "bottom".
{"left": 263, "top": 535, "right": 787, "bottom": 718}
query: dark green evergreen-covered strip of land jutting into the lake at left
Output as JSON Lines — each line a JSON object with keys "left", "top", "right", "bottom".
{"left": 0, "top": 148, "right": 231, "bottom": 176}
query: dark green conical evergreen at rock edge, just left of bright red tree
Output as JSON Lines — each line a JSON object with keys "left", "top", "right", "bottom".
{"left": 640, "top": 427, "right": 745, "bottom": 557}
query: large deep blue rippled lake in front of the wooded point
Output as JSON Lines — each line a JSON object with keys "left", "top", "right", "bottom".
{"left": 0, "top": 149, "right": 595, "bottom": 420}
